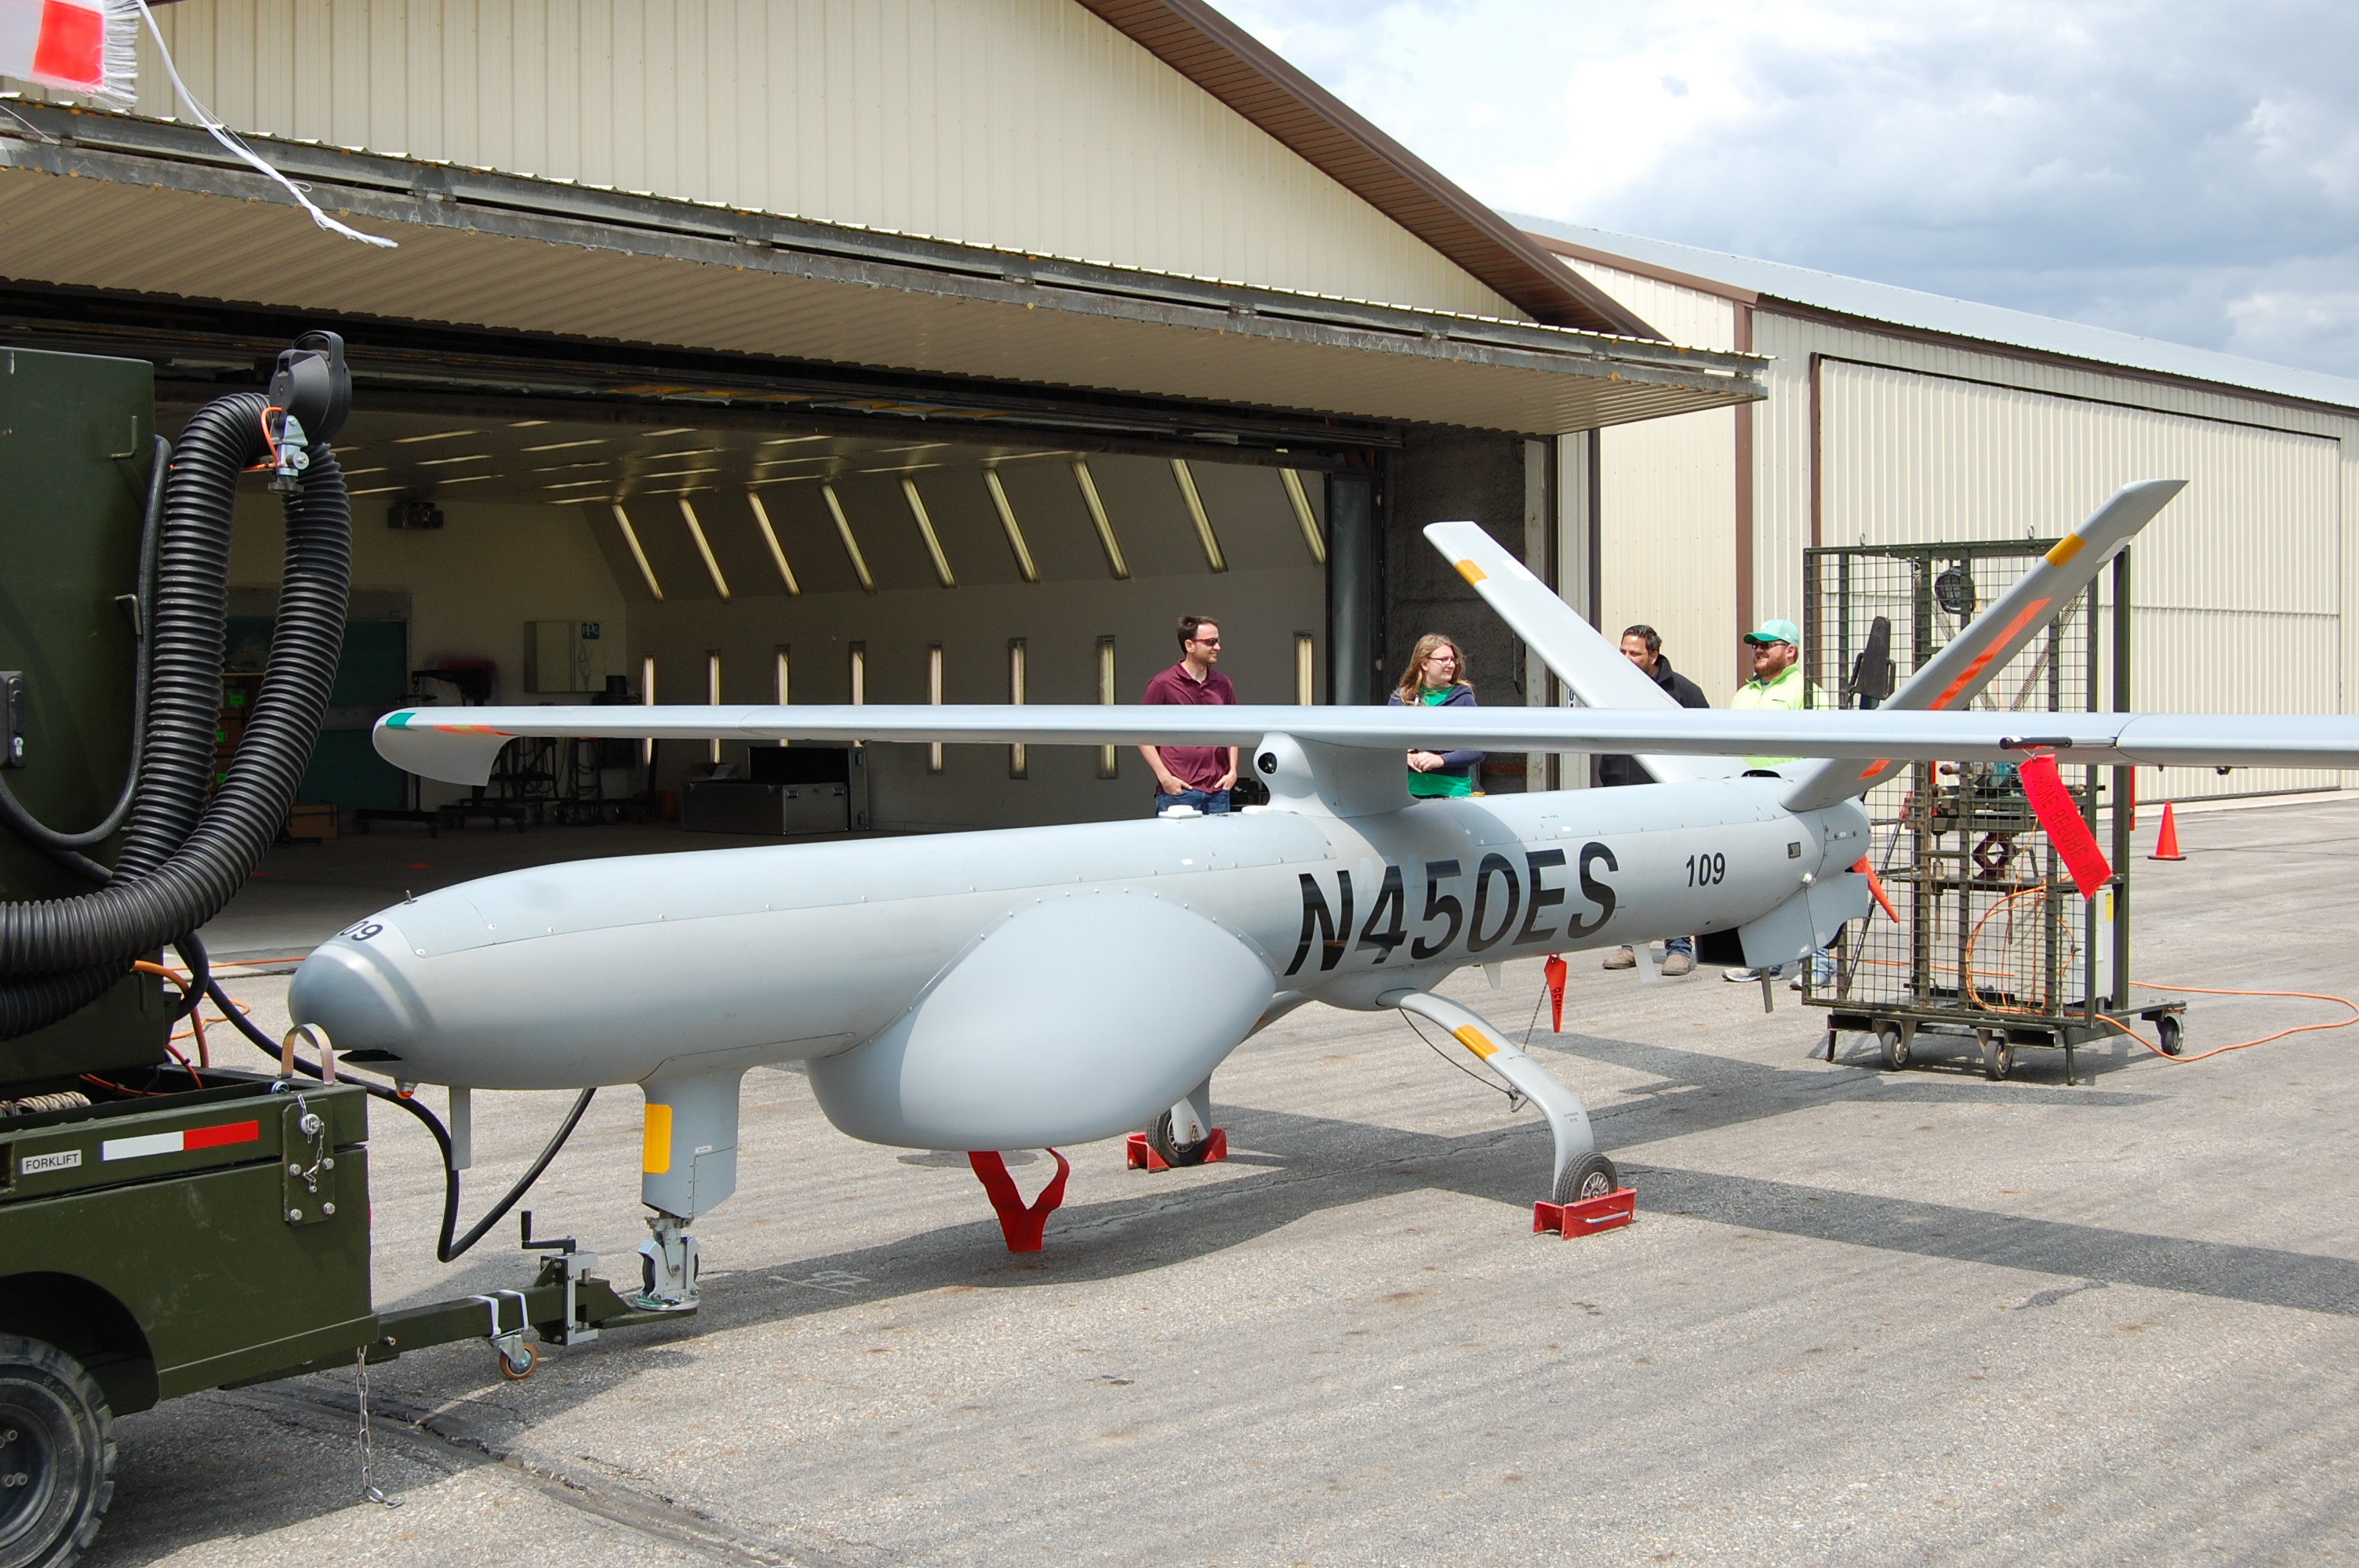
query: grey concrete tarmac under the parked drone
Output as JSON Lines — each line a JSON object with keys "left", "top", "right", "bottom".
{"left": 87, "top": 800, "right": 2359, "bottom": 1568}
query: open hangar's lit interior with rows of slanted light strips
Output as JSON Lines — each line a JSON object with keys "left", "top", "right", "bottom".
{"left": 111, "top": 310, "right": 1368, "bottom": 830}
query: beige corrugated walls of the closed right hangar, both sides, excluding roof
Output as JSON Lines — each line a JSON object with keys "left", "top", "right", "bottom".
{"left": 1566, "top": 262, "right": 2359, "bottom": 797}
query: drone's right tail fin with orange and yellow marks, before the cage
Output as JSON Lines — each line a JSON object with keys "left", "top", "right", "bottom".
{"left": 1786, "top": 479, "right": 2186, "bottom": 811}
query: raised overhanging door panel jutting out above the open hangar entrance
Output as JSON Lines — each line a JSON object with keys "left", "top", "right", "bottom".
{"left": 0, "top": 103, "right": 1762, "bottom": 434}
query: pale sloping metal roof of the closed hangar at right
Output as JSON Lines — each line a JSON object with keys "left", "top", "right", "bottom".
{"left": 1514, "top": 217, "right": 2359, "bottom": 422}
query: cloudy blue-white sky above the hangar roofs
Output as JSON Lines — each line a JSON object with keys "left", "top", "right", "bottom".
{"left": 1217, "top": 0, "right": 2359, "bottom": 377}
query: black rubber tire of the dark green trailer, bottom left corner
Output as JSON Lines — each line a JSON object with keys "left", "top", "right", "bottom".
{"left": 0, "top": 1334, "right": 115, "bottom": 1568}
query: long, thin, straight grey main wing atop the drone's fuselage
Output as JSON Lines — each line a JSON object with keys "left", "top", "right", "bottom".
{"left": 375, "top": 702, "right": 2359, "bottom": 786}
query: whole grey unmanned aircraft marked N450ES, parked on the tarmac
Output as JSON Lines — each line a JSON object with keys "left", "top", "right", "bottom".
{"left": 288, "top": 481, "right": 2359, "bottom": 1301}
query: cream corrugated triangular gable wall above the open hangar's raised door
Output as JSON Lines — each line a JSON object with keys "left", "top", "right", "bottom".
{"left": 139, "top": 0, "right": 1519, "bottom": 316}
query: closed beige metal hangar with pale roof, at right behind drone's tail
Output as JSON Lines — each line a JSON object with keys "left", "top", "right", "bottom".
{"left": 1519, "top": 220, "right": 2359, "bottom": 800}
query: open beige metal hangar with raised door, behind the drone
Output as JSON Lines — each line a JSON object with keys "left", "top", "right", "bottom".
{"left": 0, "top": 0, "right": 1762, "bottom": 828}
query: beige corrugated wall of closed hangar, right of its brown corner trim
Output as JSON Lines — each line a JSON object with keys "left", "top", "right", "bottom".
{"left": 1753, "top": 316, "right": 2359, "bottom": 797}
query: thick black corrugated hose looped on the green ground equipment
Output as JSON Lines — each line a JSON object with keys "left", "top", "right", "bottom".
{"left": 0, "top": 391, "right": 351, "bottom": 1040}
